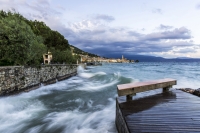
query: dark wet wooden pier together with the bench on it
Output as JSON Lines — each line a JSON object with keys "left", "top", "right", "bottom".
{"left": 115, "top": 79, "right": 200, "bottom": 133}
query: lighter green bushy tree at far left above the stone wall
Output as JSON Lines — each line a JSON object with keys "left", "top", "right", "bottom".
{"left": 0, "top": 11, "right": 45, "bottom": 65}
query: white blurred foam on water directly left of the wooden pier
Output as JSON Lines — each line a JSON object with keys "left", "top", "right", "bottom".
{"left": 44, "top": 99, "right": 116, "bottom": 133}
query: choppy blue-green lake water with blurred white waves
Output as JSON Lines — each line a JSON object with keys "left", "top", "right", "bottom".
{"left": 0, "top": 62, "right": 200, "bottom": 133}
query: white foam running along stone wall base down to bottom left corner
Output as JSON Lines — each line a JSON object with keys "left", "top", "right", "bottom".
{"left": 0, "top": 77, "right": 86, "bottom": 133}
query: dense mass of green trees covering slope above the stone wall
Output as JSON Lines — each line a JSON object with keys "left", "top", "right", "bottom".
{"left": 0, "top": 10, "right": 97, "bottom": 66}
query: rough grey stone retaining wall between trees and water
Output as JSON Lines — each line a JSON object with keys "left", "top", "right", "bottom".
{"left": 0, "top": 65, "right": 77, "bottom": 95}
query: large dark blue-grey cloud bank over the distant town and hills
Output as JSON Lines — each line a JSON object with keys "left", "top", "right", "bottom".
{"left": 63, "top": 22, "right": 193, "bottom": 57}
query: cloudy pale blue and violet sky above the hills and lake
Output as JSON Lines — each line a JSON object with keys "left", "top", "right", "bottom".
{"left": 0, "top": 0, "right": 200, "bottom": 58}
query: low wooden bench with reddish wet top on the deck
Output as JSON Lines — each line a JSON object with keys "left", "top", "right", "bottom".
{"left": 117, "top": 79, "right": 176, "bottom": 101}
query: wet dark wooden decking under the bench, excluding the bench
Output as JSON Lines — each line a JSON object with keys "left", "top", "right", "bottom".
{"left": 116, "top": 89, "right": 200, "bottom": 133}
